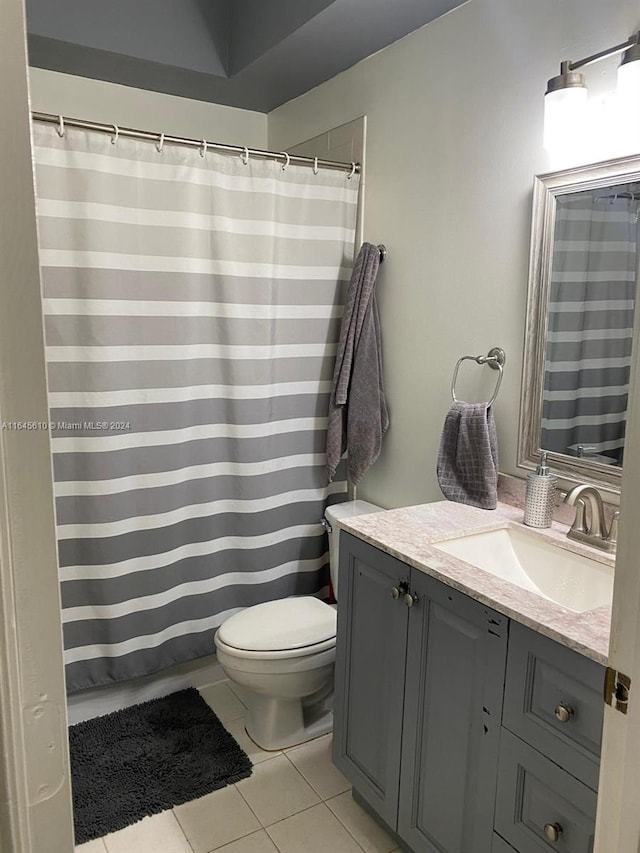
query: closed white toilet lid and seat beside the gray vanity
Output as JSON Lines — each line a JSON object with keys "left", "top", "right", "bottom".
{"left": 218, "top": 596, "right": 336, "bottom": 652}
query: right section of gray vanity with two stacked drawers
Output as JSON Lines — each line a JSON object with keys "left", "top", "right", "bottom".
{"left": 495, "top": 622, "right": 604, "bottom": 853}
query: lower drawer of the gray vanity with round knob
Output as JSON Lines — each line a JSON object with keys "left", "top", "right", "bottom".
{"left": 495, "top": 729, "right": 597, "bottom": 853}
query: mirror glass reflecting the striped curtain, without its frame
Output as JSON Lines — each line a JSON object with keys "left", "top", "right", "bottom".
{"left": 541, "top": 190, "right": 638, "bottom": 464}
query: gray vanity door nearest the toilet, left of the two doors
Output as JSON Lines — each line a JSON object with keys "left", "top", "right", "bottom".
{"left": 333, "top": 532, "right": 409, "bottom": 829}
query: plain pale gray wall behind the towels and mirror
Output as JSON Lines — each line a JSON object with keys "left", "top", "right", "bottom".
{"left": 269, "top": 0, "right": 639, "bottom": 507}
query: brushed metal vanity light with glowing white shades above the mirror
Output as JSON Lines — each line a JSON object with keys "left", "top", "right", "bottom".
{"left": 544, "top": 32, "right": 640, "bottom": 151}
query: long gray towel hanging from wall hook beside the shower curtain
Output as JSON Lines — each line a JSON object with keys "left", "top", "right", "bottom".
{"left": 327, "top": 243, "right": 389, "bottom": 485}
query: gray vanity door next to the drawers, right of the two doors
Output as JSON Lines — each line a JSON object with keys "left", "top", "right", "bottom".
{"left": 398, "top": 571, "right": 509, "bottom": 853}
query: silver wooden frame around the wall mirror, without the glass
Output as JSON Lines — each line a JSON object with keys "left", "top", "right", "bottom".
{"left": 518, "top": 150, "right": 640, "bottom": 492}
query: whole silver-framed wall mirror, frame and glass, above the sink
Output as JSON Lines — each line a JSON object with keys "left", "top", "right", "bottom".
{"left": 518, "top": 152, "right": 640, "bottom": 489}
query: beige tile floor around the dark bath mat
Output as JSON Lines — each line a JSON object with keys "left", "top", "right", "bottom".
{"left": 76, "top": 683, "right": 400, "bottom": 853}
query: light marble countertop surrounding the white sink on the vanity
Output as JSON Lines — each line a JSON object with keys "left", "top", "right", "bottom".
{"left": 340, "top": 501, "right": 615, "bottom": 664}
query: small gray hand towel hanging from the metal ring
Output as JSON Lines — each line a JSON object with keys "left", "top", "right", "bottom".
{"left": 437, "top": 403, "right": 498, "bottom": 509}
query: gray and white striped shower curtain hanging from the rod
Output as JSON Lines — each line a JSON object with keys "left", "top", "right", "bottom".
{"left": 34, "top": 124, "right": 358, "bottom": 692}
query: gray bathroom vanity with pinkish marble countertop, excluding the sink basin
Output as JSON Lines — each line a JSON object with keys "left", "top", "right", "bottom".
{"left": 333, "top": 502, "right": 613, "bottom": 853}
